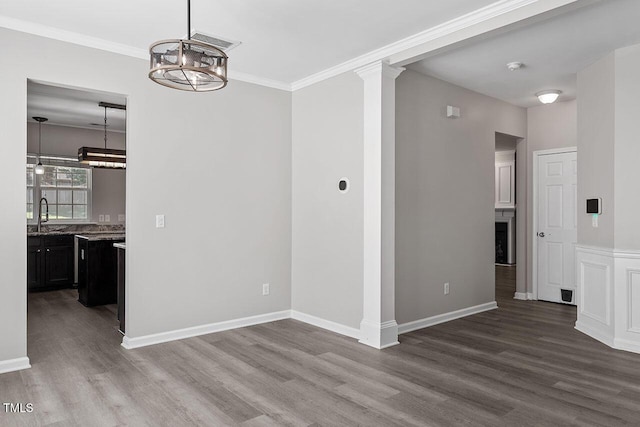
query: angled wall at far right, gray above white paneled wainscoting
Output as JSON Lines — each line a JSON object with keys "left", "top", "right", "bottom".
{"left": 576, "top": 45, "right": 640, "bottom": 353}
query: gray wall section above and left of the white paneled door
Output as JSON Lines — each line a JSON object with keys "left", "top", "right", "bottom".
{"left": 517, "top": 100, "right": 581, "bottom": 292}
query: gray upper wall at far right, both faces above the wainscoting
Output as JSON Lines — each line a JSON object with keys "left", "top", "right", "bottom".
{"left": 578, "top": 45, "right": 640, "bottom": 251}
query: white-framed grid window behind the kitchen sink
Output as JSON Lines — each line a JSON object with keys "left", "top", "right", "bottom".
{"left": 27, "top": 156, "right": 91, "bottom": 222}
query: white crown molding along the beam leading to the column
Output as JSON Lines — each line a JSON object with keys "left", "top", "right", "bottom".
{"left": 291, "top": 0, "right": 575, "bottom": 91}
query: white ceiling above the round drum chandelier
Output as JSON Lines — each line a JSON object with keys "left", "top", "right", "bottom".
{"left": 0, "top": 0, "right": 496, "bottom": 84}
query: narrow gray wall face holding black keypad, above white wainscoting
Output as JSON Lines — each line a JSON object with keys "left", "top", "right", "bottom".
{"left": 578, "top": 54, "right": 615, "bottom": 248}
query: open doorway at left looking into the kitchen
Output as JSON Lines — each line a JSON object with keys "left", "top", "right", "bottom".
{"left": 25, "top": 81, "right": 127, "bottom": 363}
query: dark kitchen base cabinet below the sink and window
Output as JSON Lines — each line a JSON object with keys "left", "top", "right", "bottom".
{"left": 27, "top": 235, "right": 73, "bottom": 291}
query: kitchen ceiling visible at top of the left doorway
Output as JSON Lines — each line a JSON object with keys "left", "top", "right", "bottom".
{"left": 27, "top": 81, "right": 127, "bottom": 132}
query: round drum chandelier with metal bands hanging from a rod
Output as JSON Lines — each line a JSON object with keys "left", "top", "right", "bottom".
{"left": 149, "top": 0, "right": 228, "bottom": 92}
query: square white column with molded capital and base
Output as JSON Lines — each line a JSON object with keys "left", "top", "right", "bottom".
{"left": 356, "top": 61, "right": 404, "bottom": 349}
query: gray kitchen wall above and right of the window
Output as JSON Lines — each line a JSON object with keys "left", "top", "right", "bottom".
{"left": 27, "top": 121, "right": 126, "bottom": 224}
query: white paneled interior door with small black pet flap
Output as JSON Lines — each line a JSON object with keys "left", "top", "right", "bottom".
{"left": 534, "top": 151, "right": 578, "bottom": 305}
